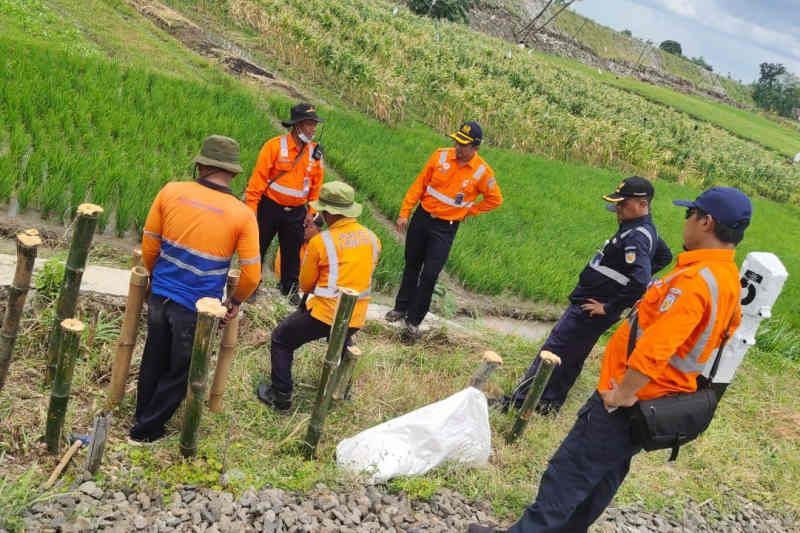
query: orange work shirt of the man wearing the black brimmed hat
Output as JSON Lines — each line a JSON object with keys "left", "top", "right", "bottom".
{"left": 244, "top": 133, "right": 325, "bottom": 212}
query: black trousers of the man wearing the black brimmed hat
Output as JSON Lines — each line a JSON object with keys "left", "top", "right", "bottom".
{"left": 256, "top": 196, "right": 306, "bottom": 294}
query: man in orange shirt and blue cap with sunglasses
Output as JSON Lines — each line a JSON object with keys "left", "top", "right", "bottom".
{"left": 469, "top": 187, "right": 752, "bottom": 533}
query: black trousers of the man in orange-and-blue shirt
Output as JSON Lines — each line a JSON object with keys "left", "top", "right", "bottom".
{"left": 131, "top": 294, "right": 197, "bottom": 440}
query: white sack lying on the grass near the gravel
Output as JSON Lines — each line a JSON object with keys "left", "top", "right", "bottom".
{"left": 336, "top": 387, "right": 491, "bottom": 483}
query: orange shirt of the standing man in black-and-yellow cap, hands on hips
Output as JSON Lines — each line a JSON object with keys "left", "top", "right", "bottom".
{"left": 400, "top": 148, "right": 503, "bottom": 220}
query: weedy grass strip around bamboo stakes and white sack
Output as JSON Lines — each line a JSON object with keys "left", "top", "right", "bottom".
{"left": 0, "top": 258, "right": 800, "bottom": 527}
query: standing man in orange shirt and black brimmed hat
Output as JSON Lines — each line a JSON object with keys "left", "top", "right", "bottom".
{"left": 245, "top": 104, "right": 324, "bottom": 298}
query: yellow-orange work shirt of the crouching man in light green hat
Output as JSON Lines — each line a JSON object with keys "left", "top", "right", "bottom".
{"left": 300, "top": 218, "right": 381, "bottom": 328}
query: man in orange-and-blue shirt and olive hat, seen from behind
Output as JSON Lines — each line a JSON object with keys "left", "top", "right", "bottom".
{"left": 130, "top": 135, "right": 261, "bottom": 442}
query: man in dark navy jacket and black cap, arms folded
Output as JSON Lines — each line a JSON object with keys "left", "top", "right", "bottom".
{"left": 501, "top": 176, "right": 672, "bottom": 414}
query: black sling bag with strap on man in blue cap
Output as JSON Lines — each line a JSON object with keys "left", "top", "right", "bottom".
{"left": 627, "top": 314, "right": 730, "bottom": 461}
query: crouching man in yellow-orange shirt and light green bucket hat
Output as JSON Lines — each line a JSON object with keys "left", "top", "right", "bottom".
{"left": 256, "top": 181, "right": 381, "bottom": 411}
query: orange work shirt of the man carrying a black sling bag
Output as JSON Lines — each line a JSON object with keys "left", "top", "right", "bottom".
{"left": 597, "top": 249, "right": 742, "bottom": 400}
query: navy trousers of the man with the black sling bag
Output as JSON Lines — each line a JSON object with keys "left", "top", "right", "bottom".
{"left": 508, "top": 392, "right": 641, "bottom": 533}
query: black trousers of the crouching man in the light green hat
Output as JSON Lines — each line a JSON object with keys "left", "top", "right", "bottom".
{"left": 270, "top": 309, "right": 358, "bottom": 394}
